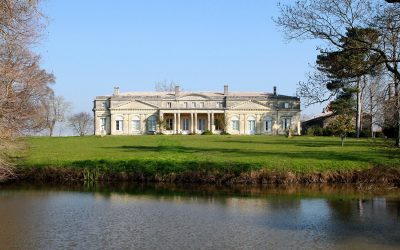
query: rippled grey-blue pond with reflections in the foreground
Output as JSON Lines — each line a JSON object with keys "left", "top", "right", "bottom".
{"left": 0, "top": 184, "right": 400, "bottom": 249}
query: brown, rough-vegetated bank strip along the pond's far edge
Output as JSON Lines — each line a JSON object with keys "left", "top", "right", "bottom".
{"left": 7, "top": 166, "right": 400, "bottom": 187}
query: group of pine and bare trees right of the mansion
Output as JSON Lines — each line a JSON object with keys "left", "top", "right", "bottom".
{"left": 275, "top": 0, "right": 400, "bottom": 146}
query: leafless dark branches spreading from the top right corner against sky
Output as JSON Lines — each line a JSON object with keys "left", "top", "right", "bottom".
{"left": 275, "top": 0, "right": 400, "bottom": 146}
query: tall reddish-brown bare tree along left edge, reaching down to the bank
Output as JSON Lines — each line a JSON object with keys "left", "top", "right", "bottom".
{"left": 0, "top": 0, "right": 54, "bottom": 181}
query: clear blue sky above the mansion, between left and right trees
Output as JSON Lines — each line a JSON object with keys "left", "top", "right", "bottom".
{"left": 37, "top": 0, "right": 322, "bottom": 114}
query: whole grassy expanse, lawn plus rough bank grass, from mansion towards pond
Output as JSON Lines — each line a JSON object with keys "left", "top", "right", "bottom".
{"left": 20, "top": 136, "right": 400, "bottom": 185}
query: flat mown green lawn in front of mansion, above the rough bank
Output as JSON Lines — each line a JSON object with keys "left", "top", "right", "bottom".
{"left": 24, "top": 135, "right": 400, "bottom": 172}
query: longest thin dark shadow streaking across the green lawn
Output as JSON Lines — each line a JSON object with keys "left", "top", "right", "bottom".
{"left": 101, "top": 146, "right": 385, "bottom": 164}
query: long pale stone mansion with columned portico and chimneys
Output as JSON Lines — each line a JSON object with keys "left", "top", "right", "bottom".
{"left": 93, "top": 85, "right": 301, "bottom": 135}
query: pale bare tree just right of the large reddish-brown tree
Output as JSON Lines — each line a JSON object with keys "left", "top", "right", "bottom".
{"left": 43, "top": 93, "right": 71, "bottom": 136}
